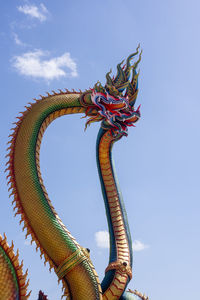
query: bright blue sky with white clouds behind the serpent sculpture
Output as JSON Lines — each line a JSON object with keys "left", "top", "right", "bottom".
{"left": 0, "top": 0, "right": 200, "bottom": 300}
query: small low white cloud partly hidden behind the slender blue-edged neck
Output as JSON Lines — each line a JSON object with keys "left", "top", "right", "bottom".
{"left": 95, "top": 230, "right": 149, "bottom": 251}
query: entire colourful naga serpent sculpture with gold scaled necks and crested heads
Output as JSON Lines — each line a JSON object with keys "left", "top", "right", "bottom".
{"left": 0, "top": 46, "right": 147, "bottom": 300}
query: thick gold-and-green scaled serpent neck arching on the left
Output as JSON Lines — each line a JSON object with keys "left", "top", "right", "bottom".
{"left": 8, "top": 93, "right": 101, "bottom": 300}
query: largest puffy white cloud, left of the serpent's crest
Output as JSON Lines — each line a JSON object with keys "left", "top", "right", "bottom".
{"left": 12, "top": 50, "right": 78, "bottom": 80}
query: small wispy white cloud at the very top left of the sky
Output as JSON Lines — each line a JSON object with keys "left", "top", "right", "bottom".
{"left": 17, "top": 3, "right": 48, "bottom": 22}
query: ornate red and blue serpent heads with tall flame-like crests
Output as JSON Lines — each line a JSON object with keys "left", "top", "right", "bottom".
{"left": 82, "top": 45, "right": 142, "bottom": 136}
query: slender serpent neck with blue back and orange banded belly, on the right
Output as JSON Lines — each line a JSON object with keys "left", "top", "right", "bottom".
{"left": 96, "top": 128, "right": 132, "bottom": 299}
